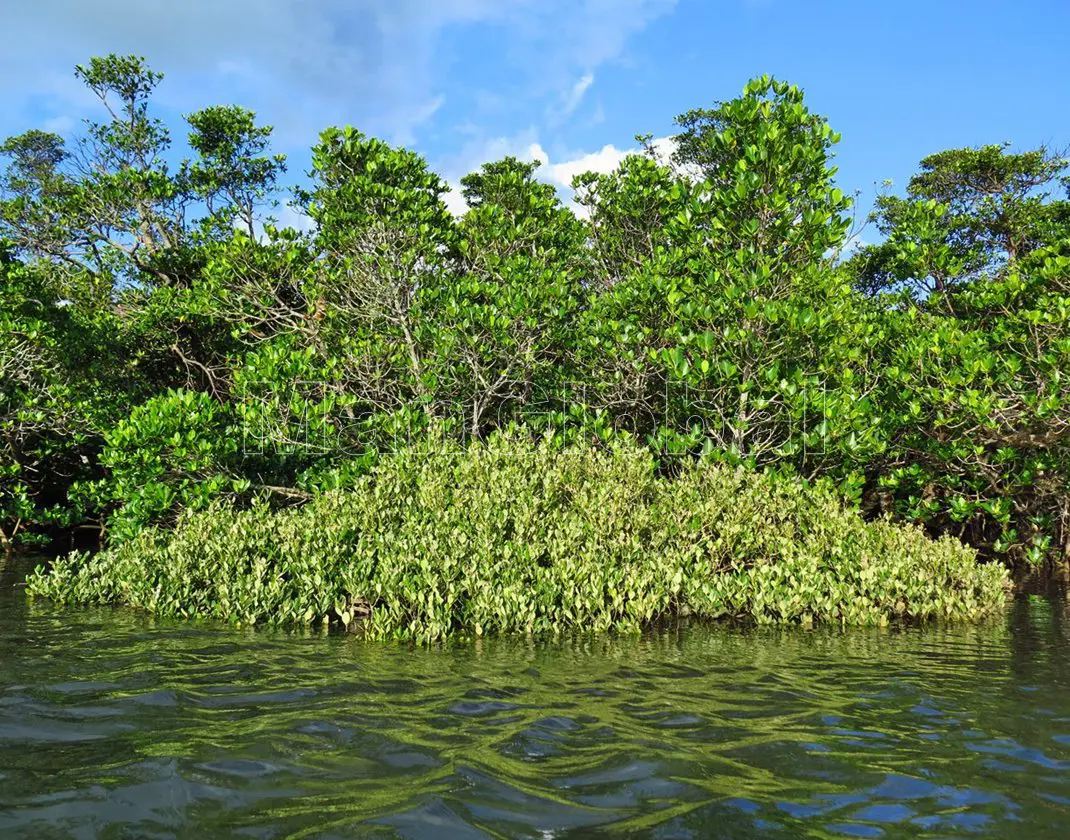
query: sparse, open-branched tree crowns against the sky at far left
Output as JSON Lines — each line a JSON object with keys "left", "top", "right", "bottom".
{"left": 0, "top": 56, "right": 282, "bottom": 295}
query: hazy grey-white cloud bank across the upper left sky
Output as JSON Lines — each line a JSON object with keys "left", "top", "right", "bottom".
{"left": 0, "top": 0, "right": 675, "bottom": 147}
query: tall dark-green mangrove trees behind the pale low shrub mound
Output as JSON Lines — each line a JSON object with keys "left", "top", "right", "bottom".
{"left": 0, "top": 56, "right": 1070, "bottom": 594}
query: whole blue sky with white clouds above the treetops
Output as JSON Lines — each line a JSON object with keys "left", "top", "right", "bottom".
{"left": 0, "top": 0, "right": 1070, "bottom": 225}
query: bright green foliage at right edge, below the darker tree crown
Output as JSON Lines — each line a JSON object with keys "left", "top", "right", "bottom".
{"left": 877, "top": 250, "right": 1070, "bottom": 565}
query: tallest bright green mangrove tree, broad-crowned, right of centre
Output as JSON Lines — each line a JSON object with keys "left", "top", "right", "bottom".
{"left": 578, "top": 79, "right": 868, "bottom": 478}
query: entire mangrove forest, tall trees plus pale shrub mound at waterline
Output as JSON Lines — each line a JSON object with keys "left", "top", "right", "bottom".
{"left": 0, "top": 55, "right": 1070, "bottom": 642}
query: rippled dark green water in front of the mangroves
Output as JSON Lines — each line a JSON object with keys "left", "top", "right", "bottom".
{"left": 0, "top": 552, "right": 1070, "bottom": 840}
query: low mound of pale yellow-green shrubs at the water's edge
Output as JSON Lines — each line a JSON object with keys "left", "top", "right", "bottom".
{"left": 29, "top": 436, "right": 1007, "bottom": 641}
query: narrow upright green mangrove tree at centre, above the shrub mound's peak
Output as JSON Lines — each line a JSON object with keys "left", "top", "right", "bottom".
{"left": 434, "top": 158, "right": 587, "bottom": 438}
